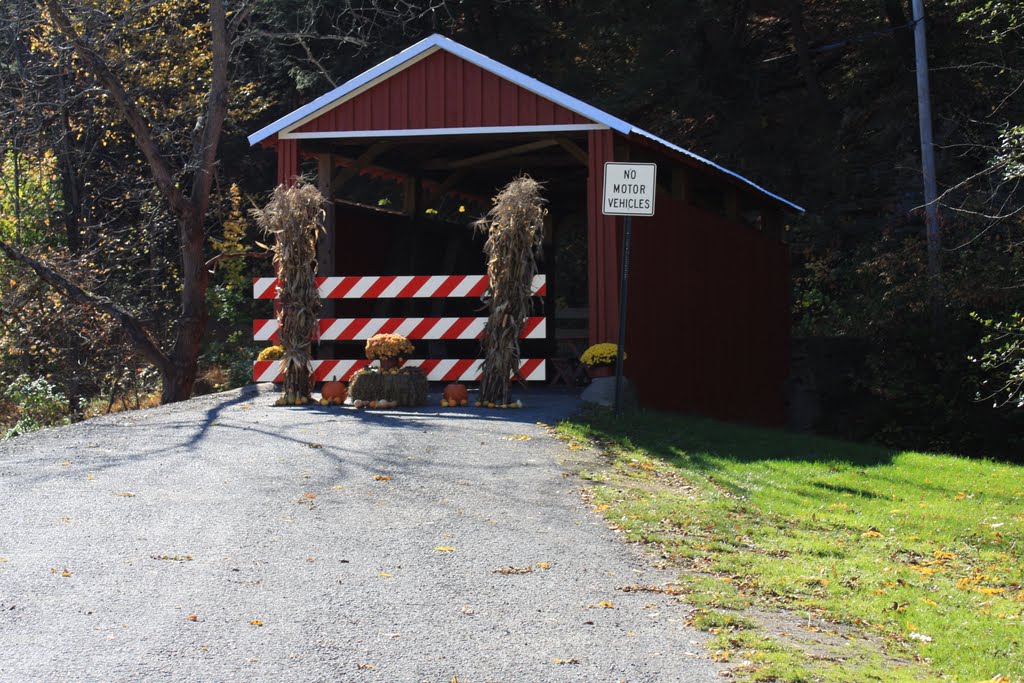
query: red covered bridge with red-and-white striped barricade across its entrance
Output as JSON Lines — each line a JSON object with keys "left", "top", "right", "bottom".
{"left": 249, "top": 35, "right": 802, "bottom": 424}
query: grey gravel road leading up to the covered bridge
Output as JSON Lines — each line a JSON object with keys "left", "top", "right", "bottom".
{"left": 0, "top": 387, "right": 720, "bottom": 683}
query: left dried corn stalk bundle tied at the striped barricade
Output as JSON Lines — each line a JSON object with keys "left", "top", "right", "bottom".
{"left": 252, "top": 180, "right": 325, "bottom": 402}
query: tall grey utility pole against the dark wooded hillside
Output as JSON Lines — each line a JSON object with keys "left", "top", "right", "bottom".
{"left": 913, "top": 0, "right": 942, "bottom": 326}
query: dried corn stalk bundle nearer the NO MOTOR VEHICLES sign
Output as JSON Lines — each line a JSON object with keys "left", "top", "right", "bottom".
{"left": 474, "top": 175, "right": 548, "bottom": 405}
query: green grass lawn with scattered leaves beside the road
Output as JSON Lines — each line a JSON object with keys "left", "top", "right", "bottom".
{"left": 559, "top": 410, "right": 1024, "bottom": 683}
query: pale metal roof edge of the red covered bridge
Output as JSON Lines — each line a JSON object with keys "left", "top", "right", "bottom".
{"left": 243, "top": 34, "right": 804, "bottom": 213}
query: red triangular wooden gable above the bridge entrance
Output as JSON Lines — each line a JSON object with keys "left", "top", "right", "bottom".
{"left": 297, "top": 50, "right": 592, "bottom": 132}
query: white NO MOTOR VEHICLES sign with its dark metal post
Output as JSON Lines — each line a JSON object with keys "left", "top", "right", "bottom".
{"left": 601, "top": 162, "right": 657, "bottom": 416}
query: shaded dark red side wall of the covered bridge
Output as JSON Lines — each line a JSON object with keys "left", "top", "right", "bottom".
{"left": 626, "top": 193, "right": 790, "bottom": 425}
